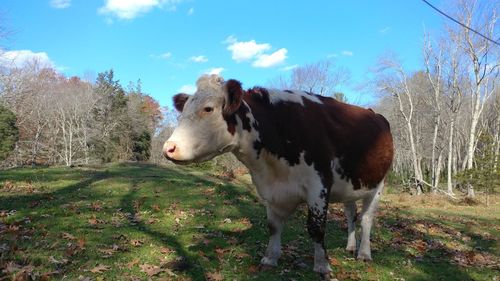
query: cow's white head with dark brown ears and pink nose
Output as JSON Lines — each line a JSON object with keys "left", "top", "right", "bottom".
{"left": 163, "top": 75, "right": 243, "bottom": 164}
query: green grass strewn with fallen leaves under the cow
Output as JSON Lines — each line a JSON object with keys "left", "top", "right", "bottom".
{"left": 0, "top": 164, "right": 500, "bottom": 280}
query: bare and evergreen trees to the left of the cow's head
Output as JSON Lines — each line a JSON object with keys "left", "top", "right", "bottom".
{"left": 0, "top": 61, "right": 163, "bottom": 166}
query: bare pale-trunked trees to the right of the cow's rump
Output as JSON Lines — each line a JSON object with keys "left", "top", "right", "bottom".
{"left": 374, "top": 0, "right": 500, "bottom": 197}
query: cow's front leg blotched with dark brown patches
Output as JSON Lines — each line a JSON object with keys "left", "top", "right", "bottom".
{"left": 307, "top": 189, "right": 332, "bottom": 274}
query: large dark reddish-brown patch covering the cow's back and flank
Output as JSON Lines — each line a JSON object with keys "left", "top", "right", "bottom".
{"left": 244, "top": 88, "right": 393, "bottom": 189}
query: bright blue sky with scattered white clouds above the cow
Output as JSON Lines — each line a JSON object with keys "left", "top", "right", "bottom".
{"left": 0, "top": 0, "right": 446, "bottom": 106}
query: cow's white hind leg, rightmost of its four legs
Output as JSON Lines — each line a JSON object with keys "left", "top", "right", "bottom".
{"left": 358, "top": 181, "right": 384, "bottom": 260}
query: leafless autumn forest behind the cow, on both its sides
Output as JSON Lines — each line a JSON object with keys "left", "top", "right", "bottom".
{"left": 0, "top": 1, "right": 500, "bottom": 197}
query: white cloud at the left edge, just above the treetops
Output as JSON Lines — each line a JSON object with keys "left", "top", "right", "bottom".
{"left": 0, "top": 50, "right": 55, "bottom": 68}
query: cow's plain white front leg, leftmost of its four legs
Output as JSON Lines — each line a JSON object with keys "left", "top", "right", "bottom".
{"left": 260, "top": 204, "right": 289, "bottom": 266}
